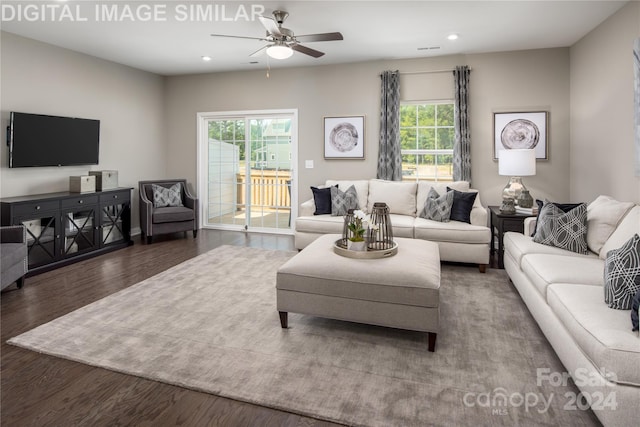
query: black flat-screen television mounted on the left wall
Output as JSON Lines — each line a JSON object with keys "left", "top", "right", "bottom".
{"left": 8, "top": 112, "right": 100, "bottom": 168}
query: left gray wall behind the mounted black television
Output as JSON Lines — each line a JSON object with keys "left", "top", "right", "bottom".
{"left": 0, "top": 32, "right": 167, "bottom": 231}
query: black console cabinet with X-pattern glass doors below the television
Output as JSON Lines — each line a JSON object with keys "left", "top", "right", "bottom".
{"left": 0, "top": 188, "right": 133, "bottom": 276}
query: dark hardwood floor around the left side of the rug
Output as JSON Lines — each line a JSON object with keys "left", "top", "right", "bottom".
{"left": 0, "top": 230, "right": 336, "bottom": 427}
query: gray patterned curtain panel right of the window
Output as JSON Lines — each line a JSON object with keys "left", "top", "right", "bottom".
{"left": 453, "top": 65, "right": 471, "bottom": 182}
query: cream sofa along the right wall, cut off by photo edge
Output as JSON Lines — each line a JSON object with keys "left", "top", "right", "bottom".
{"left": 504, "top": 196, "right": 640, "bottom": 426}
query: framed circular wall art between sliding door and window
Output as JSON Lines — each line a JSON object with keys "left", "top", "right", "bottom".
{"left": 324, "top": 116, "right": 364, "bottom": 159}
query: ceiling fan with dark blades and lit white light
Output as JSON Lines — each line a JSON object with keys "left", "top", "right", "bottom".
{"left": 211, "top": 10, "right": 342, "bottom": 59}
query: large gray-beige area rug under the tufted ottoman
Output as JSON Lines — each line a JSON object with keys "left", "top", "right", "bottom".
{"left": 9, "top": 246, "right": 597, "bottom": 426}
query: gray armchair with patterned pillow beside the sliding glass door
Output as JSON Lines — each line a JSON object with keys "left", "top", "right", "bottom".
{"left": 138, "top": 179, "right": 198, "bottom": 243}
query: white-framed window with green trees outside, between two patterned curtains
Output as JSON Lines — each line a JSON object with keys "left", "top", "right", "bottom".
{"left": 400, "top": 101, "right": 454, "bottom": 181}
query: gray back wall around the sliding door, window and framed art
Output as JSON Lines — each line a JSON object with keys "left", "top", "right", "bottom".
{"left": 166, "top": 49, "right": 569, "bottom": 211}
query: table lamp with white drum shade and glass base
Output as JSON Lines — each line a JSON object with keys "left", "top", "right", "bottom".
{"left": 498, "top": 150, "right": 536, "bottom": 208}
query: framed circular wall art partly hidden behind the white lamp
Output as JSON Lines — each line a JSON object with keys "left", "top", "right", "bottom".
{"left": 493, "top": 111, "right": 549, "bottom": 160}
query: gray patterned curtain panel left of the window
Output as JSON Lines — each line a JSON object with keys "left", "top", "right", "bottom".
{"left": 377, "top": 71, "right": 402, "bottom": 181}
